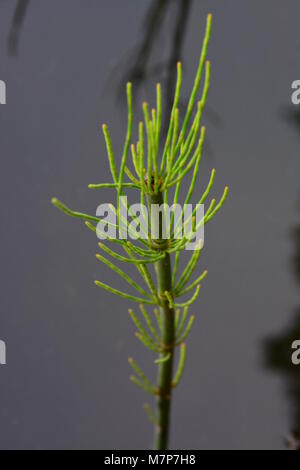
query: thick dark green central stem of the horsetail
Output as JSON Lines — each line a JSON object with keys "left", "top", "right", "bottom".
{"left": 148, "top": 192, "right": 175, "bottom": 450}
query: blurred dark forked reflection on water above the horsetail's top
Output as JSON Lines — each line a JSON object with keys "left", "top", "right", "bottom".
{"left": 118, "top": 0, "right": 221, "bottom": 160}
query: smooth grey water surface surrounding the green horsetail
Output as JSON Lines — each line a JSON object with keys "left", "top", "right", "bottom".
{"left": 0, "top": 0, "right": 300, "bottom": 449}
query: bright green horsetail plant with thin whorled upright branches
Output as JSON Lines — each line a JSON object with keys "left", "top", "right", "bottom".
{"left": 52, "top": 14, "right": 228, "bottom": 449}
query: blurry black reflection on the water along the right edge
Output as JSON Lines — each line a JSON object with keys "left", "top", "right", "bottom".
{"left": 264, "top": 194, "right": 300, "bottom": 450}
